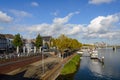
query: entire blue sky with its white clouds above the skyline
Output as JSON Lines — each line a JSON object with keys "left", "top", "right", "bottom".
{"left": 0, "top": 0, "right": 120, "bottom": 44}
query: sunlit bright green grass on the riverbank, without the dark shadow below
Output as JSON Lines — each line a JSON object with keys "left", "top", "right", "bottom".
{"left": 61, "top": 54, "right": 81, "bottom": 75}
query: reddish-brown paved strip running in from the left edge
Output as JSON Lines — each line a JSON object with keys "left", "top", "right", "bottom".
{"left": 0, "top": 56, "right": 41, "bottom": 74}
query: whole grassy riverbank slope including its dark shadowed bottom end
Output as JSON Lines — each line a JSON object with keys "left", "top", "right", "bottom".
{"left": 56, "top": 54, "right": 82, "bottom": 80}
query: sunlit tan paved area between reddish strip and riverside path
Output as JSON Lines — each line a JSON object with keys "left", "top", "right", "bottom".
{"left": 7, "top": 57, "right": 61, "bottom": 79}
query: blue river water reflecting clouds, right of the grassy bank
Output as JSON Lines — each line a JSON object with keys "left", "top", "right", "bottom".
{"left": 74, "top": 48, "right": 120, "bottom": 80}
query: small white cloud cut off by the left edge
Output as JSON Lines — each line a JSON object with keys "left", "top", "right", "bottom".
{"left": 0, "top": 11, "right": 13, "bottom": 23}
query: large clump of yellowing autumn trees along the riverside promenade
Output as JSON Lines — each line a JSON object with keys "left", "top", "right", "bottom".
{"left": 52, "top": 34, "right": 82, "bottom": 51}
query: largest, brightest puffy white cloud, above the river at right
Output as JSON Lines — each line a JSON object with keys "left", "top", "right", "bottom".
{"left": 88, "top": 14, "right": 120, "bottom": 33}
